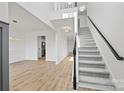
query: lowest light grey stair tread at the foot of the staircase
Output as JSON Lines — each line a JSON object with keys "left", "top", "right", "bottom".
{"left": 79, "top": 82, "right": 115, "bottom": 91}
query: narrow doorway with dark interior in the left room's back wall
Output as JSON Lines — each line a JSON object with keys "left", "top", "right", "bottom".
{"left": 38, "top": 36, "right": 46, "bottom": 60}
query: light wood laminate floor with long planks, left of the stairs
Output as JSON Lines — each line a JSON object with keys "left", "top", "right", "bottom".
{"left": 10, "top": 57, "right": 92, "bottom": 91}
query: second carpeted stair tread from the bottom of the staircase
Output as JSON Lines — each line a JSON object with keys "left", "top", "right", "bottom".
{"left": 79, "top": 75, "right": 113, "bottom": 85}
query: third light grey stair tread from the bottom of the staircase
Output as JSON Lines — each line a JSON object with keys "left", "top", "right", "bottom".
{"left": 79, "top": 66, "right": 109, "bottom": 74}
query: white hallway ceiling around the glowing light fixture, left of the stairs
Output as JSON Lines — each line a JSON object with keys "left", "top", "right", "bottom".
{"left": 51, "top": 18, "right": 74, "bottom": 40}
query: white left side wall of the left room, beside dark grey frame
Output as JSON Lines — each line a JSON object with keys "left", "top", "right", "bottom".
{"left": 9, "top": 30, "right": 25, "bottom": 63}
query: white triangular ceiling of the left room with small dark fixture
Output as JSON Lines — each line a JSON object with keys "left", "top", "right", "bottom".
{"left": 9, "top": 3, "right": 51, "bottom": 32}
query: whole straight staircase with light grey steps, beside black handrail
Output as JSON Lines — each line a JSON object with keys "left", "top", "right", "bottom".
{"left": 78, "top": 27, "right": 115, "bottom": 90}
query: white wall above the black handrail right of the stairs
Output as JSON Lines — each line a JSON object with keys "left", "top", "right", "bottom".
{"left": 88, "top": 3, "right": 124, "bottom": 56}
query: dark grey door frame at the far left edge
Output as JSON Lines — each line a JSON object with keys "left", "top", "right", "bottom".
{"left": 0, "top": 21, "right": 9, "bottom": 91}
